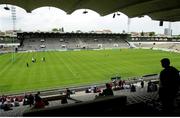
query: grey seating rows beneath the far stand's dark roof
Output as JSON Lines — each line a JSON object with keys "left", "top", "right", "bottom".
{"left": 19, "top": 34, "right": 129, "bottom": 50}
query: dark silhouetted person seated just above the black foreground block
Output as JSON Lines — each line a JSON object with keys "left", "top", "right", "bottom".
{"left": 99, "top": 83, "right": 114, "bottom": 96}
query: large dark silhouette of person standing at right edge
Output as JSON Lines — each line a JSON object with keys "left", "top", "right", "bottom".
{"left": 159, "top": 58, "right": 180, "bottom": 113}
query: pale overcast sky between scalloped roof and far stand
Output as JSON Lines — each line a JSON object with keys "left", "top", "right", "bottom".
{"left": 0, "top": 5, "right": 180, "bottom": 35}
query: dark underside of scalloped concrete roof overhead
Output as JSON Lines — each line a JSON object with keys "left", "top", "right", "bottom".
{"left": 0, "top": 0, "right": 180, "bottom": 22}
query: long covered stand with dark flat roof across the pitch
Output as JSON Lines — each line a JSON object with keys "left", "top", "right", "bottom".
{"left": 17, "top": 32, "right": 129, "bottom": 51}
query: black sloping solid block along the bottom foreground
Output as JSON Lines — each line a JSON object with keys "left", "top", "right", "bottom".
{"left": 23, "top": 96, "right": 127, "bottom": 116}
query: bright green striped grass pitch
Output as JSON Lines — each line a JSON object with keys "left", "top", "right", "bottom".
{"left": 0, "top": 49, "right": 180, "bottom": 94}
